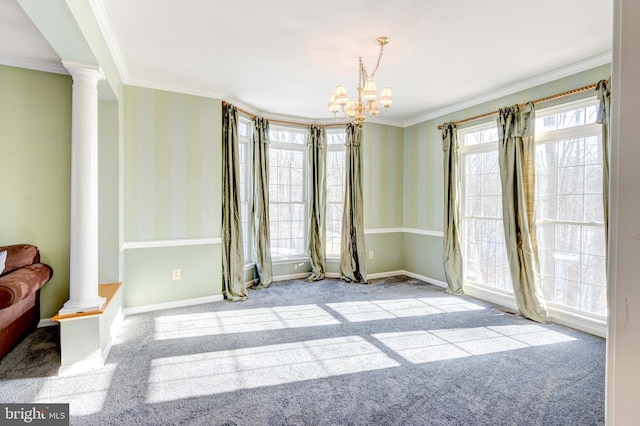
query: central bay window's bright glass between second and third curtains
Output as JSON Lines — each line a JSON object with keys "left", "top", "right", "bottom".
{"left": 269, "top": 126, "right": 308, "bottom": 259}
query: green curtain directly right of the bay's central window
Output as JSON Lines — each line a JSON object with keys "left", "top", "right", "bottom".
{"left": 307, "top": 125, "right": 327, "bottom": 281}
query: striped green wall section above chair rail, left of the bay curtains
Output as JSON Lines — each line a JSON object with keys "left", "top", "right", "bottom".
{"left": 124, "top": 86, "right": 222, "bottom": 241}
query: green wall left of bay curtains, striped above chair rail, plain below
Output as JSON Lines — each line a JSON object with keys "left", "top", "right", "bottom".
{"left": 123, "top": 86, "right": 222, "bottom": 307}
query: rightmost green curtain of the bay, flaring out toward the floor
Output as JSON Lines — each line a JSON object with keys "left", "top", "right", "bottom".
{"left": 340, "top": 123, "right": 367, "bottom": 284}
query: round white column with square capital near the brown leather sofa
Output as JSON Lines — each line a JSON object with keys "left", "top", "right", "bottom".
{"left": 60, "top": 62, "right": 105, "bottom": 315}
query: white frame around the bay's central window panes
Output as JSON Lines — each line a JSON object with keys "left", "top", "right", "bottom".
{"left": 269, "top": 124, "right": 309, "bottom": 265}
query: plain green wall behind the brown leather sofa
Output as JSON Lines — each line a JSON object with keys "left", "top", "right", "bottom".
{"left": 0, "top": 65, "right": 71, "bottom": 318}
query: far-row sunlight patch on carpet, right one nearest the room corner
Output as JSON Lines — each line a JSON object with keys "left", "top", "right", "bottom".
{"left": 327, "top": 296, "right": 486, "bottom": 322}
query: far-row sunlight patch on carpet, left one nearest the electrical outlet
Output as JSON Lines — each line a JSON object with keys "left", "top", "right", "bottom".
{"left": 154, "top": 305, "right": 340, "bottom": 340}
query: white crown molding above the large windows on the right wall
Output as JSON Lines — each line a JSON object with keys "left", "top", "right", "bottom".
{"left": 402, "top": 51, "right": 612, "bottom": 127}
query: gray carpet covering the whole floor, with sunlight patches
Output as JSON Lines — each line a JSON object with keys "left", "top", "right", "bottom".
{"left": 0, "top": 277, "right": 605, "bottom": 425}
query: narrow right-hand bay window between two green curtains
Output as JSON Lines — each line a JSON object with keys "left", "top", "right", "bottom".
{"left": 326, "top": 130, "right": 346, "bottom": 257}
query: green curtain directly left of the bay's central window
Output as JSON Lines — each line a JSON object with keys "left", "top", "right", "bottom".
{"left": 252, "top": 117, "right": 273, "bottom": 289}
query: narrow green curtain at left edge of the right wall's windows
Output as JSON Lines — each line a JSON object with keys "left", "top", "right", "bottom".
{"left": 442, "top": 123, "right": 463, "bottom": 294}
